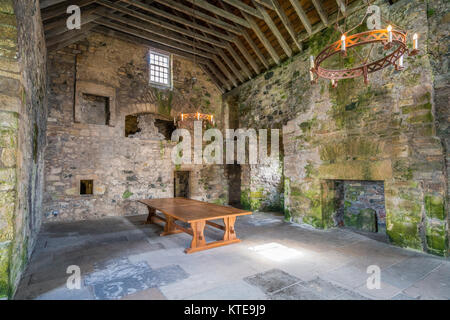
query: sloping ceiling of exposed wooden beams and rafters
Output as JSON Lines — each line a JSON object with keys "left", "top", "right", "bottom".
{"left": 40, "top": 0, "right": 363, "bottom": 91}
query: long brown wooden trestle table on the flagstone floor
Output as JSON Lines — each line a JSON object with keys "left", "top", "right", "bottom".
{"left": 139, "top": 198, "right": 252, "bottom": 253}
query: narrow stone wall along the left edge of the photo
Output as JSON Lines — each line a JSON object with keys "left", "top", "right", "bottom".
{"left": 0, "top": 0, "right": 47, "bottom": 298}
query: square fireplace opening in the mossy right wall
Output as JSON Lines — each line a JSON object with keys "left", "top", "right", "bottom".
{"left": 334, "top": 180, "right": 386, "bottom": 235}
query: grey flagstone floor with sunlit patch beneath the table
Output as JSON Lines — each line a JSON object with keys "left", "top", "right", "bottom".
{"left": 15, "top": 213, "right": 450, "bottom": 300}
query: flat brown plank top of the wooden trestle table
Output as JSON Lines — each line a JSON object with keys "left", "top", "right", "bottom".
{"left": 139, "top": 198, "right": 252, "bottom": 223}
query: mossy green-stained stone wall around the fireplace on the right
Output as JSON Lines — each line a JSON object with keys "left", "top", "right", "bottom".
{"left": 226, "top": 0, "right": 448, "bottom": 255}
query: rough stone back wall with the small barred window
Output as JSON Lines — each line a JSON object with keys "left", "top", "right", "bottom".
{"left": 44, "top": 34, "right": 227, "bottom": 221}
